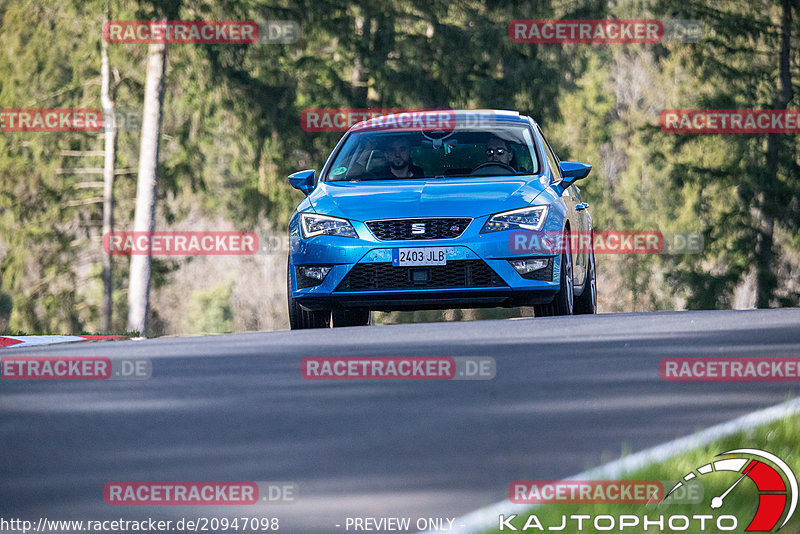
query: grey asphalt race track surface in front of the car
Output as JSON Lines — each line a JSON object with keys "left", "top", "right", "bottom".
{"left": 0, "top": 309, "right": 800, "bottom": 533}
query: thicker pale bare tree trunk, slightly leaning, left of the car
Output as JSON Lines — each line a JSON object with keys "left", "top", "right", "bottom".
{"left": 128, "top": 39, "right": 167, "bottom": 336}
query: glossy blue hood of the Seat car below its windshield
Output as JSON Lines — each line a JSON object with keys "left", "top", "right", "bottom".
{"left": 308, "top": 175, "right": 547, "bottom": 221}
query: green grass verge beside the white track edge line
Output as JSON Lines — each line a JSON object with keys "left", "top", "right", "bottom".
{"left": 486, "top": 415, "right": 800, "bottom": 534}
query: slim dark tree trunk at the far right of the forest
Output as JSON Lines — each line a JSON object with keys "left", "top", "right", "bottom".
{"left": 755, "top": 0, "right": 793, "bottom": 308}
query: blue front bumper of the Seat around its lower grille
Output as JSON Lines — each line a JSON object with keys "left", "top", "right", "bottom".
{"left": 289, "top": 218, "right": 561, "bottom": 311}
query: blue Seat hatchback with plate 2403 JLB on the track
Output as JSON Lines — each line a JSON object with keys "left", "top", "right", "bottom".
{"left": 287, "top": 110, "right": 597, "bottom": 329}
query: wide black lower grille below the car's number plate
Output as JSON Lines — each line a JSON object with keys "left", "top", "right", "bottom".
{"left": 335, "top": 260, "right": 506, "bottom": 291}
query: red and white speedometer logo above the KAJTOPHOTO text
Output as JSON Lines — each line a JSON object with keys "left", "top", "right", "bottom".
{"left": 664, "top": 449, "right": 797, "bottom": 532}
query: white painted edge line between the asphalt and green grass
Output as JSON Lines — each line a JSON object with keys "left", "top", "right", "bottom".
{"left": 422, "top": 397, "right": 800, "bottom": 534}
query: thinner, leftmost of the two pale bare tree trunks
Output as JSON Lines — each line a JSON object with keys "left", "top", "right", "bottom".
{"left": 100, "top": 6, "right": 117, "bottom": 334}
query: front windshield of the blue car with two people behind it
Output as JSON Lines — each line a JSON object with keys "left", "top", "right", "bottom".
{"left": 324, "top": 125, "right": 539, "bottom": 182}
